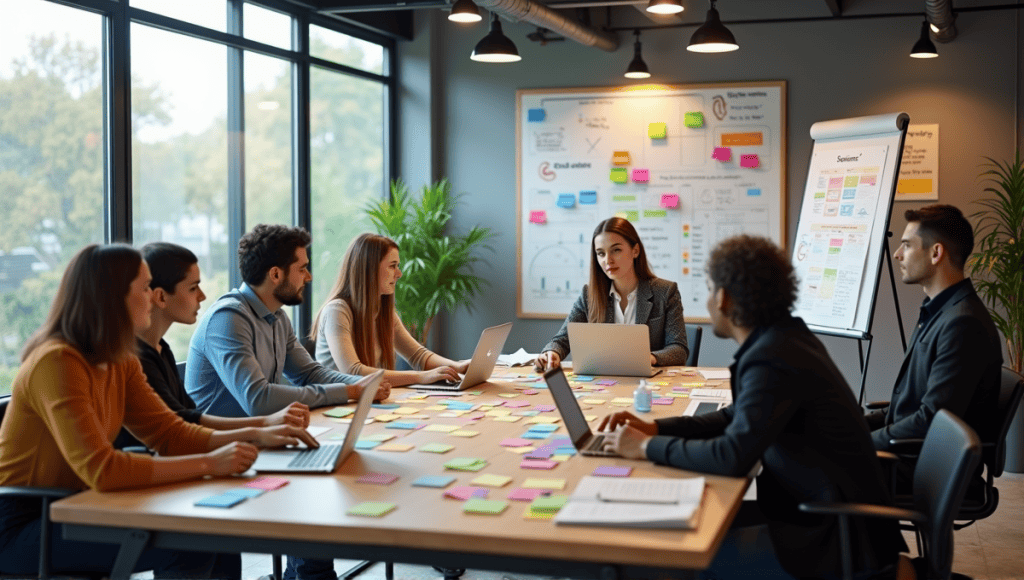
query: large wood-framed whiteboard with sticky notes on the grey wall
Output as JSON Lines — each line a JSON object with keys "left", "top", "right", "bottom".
{"left": 516, "top": 81, "right": 786, "bottom": 322}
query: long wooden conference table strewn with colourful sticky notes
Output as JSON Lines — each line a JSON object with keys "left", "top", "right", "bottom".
{"left": 51, "top": 367, "right": 750, "bottom": 580}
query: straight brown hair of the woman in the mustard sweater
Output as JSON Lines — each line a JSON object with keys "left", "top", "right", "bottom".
{"left": 22, "top": 244, "right": 142, "bottom": 365}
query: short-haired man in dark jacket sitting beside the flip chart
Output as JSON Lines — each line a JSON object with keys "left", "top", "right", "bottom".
{"left": 867, "top": 204, "right": 1002, "bottom": 454}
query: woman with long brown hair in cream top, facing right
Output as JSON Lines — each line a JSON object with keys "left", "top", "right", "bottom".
{"left": 309, "top": 234, "right": 469, "bottom": 386}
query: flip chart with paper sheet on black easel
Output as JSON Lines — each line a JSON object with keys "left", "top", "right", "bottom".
{"left": 793, "top": 113, "right": 910, "bottom": 338}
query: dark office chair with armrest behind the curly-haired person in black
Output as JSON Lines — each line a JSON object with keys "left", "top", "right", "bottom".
{"left": 800, "top": 409, "right": 981, "bottom": 580}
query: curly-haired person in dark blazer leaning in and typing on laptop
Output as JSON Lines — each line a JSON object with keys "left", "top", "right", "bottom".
{"left": 601, "top": 236, "right": 906, "bottom": 578}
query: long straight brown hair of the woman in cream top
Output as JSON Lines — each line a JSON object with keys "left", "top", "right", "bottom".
{"left": 309, "top": 234, "right": 398, "bottom": 370}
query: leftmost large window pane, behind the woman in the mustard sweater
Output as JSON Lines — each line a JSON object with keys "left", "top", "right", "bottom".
{"left": 0, "top": 0, "right": 103, "bottom": 395}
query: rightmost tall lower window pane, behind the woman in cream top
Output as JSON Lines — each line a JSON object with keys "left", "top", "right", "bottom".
{"left": 309, "top": 67, "right": 386, "bottom": 312}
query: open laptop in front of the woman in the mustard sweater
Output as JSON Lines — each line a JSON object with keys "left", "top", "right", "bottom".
{"left": 251, "top": 370, "right": 384, "bottom": 473}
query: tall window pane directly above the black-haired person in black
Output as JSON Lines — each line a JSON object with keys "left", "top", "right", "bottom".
{"left": 131, "top": 25, "right": 234, "bottom": 361}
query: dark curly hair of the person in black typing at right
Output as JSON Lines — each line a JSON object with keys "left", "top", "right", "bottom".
{"left": 708, "top": 235, "right": 797, "bottom": 328}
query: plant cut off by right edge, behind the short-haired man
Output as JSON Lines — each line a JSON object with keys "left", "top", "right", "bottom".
{"left": 971, "top": 150, "right": 1024, "bottom": 372}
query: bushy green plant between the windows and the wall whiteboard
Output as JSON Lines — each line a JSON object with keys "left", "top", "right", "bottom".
{"left": 366, "top": 179, "right": 494, "bottom": 343}
